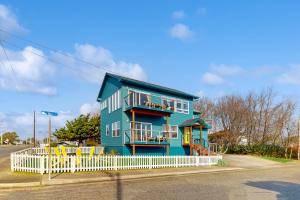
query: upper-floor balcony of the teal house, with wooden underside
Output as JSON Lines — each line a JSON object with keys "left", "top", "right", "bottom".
{"left": 123, "top": 91, "right": 175, "bottom": 116}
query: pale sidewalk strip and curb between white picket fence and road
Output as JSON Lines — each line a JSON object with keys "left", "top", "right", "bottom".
{"left": 0, "top": 166, "right": 242, "bottom": 188}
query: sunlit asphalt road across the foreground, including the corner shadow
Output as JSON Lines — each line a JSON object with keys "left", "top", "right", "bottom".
{"left": 0, "top": 166, "right": 300, "bottom": 200}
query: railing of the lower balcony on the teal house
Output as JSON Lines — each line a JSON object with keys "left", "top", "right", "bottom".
{"left": 124, "top": 129, "right": 169, "bottom": 144}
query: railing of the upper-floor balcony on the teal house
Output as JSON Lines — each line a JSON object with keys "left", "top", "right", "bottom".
{"left": 123, "top": 91, "right": 175, "bottom": 113}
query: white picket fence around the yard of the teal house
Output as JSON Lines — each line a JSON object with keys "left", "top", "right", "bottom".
{"left": 11, "top": 149, "right": 222, "bottom": 174}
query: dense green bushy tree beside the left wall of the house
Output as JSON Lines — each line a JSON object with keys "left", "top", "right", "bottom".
{"left": 54, "top": 114, "right": 100, "bottom": 144}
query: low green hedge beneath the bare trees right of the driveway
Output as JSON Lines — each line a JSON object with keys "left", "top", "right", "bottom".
{"left": 227, "top": 144, "right": 284, "bottom": 157}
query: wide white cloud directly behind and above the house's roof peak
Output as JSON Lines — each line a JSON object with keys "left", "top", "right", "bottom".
{"left": 54, "top": 44, "right": 147, "bottom": 83}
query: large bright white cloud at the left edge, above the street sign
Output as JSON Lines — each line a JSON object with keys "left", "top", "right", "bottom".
{"left": 0, "top": 46, "right": 57, "bottom": 96}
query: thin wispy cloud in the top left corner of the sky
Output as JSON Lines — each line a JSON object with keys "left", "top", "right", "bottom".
{"left": 0, "top": 4, "right": 26, "bottom": 38}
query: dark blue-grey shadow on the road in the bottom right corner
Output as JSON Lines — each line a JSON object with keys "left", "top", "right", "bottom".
{"left": 246, "top": 181, "right": 300, "bottom": 200}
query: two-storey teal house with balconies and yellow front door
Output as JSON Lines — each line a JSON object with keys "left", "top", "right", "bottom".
{"left": 97, "top": 73, "right": 210, "bottom": 155}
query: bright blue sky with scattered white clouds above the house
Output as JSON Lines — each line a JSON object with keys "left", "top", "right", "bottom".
{"left": 0, "top": 0, "right": 300, "bottom": 138}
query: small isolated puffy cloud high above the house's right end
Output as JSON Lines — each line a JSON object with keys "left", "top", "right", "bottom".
{"left": 170, "top": 23, "right": 194, "bottom": 41}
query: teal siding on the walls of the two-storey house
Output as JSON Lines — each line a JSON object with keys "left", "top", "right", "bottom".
{"left": 100, "top": 77, "right": 208, "bottom": 155}
